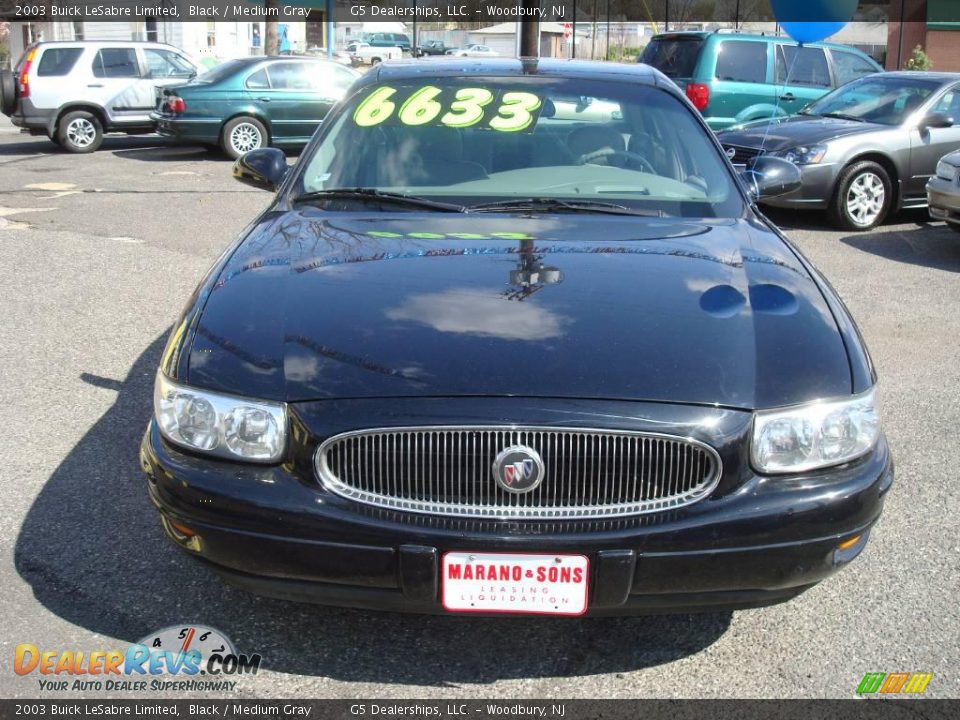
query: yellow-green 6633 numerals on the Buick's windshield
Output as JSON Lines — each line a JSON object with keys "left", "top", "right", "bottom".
{"left": 353, "top": 85, "right": 542, "bottom": 132}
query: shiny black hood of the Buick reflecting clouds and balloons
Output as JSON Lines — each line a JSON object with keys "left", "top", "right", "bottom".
{"left": 186, "top": 209, "right": 851, "bottom": 408}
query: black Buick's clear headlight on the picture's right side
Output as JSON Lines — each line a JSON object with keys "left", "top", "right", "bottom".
{"left": 750, "top": 389, "right": 880, "bottom": 473}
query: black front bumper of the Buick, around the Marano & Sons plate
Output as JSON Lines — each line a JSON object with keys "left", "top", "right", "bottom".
{"left": 141, "top": 400, "right": 893, "bottom": 615}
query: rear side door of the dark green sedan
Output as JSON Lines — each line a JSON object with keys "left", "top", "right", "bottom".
{"left": 248, "top": 60, "right": 328, "bottom": 143}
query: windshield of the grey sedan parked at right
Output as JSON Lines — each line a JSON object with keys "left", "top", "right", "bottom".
{"left": 802, "top": 75, "right": 940, "bottom": 125}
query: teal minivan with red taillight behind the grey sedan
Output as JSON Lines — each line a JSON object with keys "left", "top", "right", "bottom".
{"left": 639, "top": 31, "right": 883, "bottom": 130}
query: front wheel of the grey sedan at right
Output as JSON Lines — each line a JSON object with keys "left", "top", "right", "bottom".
{"left": 830, "top": 160, "right": 893, "bottom": 231}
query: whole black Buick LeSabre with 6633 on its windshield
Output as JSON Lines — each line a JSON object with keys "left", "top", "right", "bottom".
{"left": 141, "top": 58, "right": 893, "bottom": 615}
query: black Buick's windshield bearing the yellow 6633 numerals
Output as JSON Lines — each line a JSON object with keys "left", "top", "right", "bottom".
{"left": 299, "top": 77, "right": 743, "bottom": 217}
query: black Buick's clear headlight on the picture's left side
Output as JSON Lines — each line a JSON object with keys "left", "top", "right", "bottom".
{"left": 153, "top": 372, "right": 287, "bottom": 462}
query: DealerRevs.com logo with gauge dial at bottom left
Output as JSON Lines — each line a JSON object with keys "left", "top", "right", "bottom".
{"left": 13, "top": 625, "right": 261, "bottom": 692}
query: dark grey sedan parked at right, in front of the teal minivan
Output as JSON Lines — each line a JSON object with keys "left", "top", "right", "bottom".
{"left": 718, "top": 72, "right": 960, "bottom": 230}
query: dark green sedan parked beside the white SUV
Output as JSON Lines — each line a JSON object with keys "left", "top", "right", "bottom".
{"left": 150, "top": 57, "right": 360, "bottom": 159}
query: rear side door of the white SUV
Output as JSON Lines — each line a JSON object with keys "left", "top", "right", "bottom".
{"left": 84, "top": 46, "right": 156, "bottom": 125}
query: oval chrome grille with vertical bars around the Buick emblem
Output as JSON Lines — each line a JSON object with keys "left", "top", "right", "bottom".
{"left": 316, "top": 427, "right": 721, "bottom": 519}
